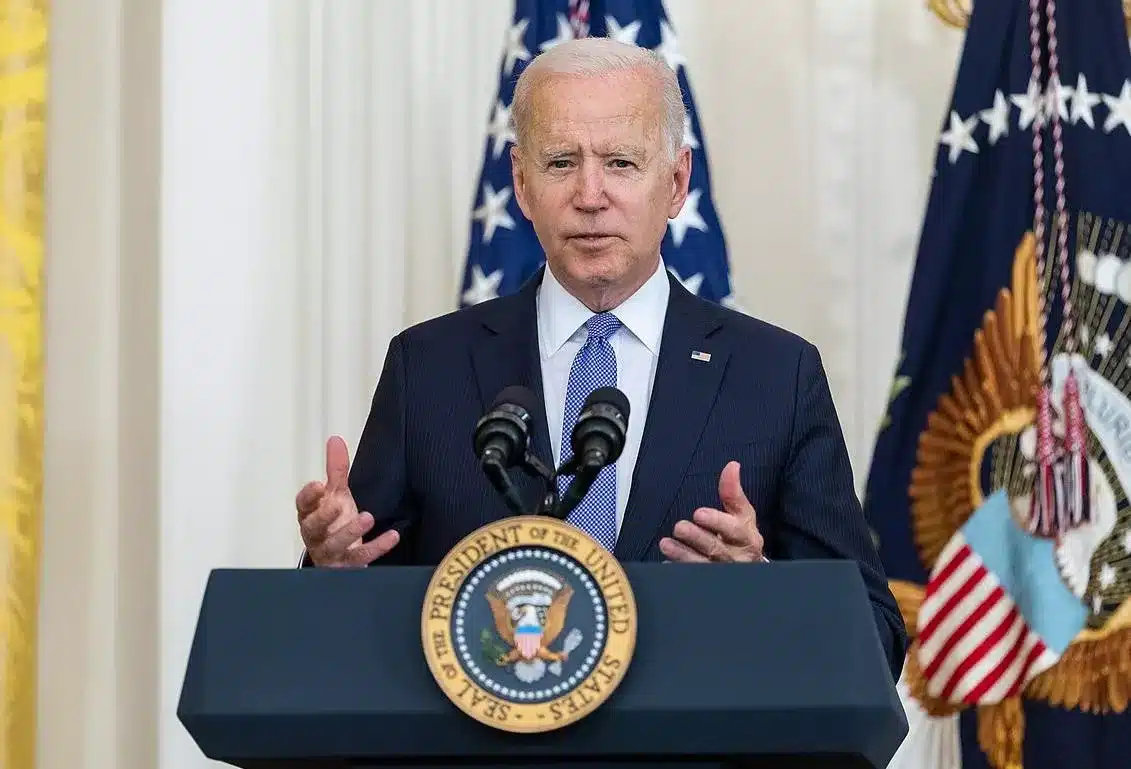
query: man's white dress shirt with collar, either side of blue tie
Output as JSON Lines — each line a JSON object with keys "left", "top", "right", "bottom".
{"left": 537, "top": 260, "right": 671, "bottom": 534}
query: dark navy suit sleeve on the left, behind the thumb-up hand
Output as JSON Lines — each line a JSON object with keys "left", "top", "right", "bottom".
{"left": 302, "top": 336, "right": 416, "bottom": 567}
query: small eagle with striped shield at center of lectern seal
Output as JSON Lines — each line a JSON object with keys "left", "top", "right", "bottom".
{"left": 485, "top": 569, "right": 581, "bottom": 683}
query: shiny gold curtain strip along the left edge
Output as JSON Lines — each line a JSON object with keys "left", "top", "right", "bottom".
{"left": 0, "top": 0, "right": 48, "bottom": 769}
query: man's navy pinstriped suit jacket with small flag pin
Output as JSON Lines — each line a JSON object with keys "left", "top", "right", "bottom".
{"left": 339, "top": 271, "right": 907, "bottom": 679}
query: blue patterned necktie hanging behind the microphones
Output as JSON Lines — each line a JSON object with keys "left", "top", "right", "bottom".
{"left": 558, "top": 312, "right": 621, "bottom": 552}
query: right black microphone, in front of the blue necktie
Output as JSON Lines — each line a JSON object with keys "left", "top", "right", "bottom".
{"left": 553, "top": 387, "right": 630, "bottom": 520}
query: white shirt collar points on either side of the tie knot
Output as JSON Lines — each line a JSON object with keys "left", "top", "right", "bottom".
{"left": 537, "top": 259, "right": 671, "bottom": 357}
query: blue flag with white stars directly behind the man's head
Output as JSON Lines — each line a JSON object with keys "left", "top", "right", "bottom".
{"left": 459, "top": 0, "right": 737, "bottom": 306}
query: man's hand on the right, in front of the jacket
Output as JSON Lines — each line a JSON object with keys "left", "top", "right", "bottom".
{"left": 659, "top": 461, "right": 765, "bottom": 563}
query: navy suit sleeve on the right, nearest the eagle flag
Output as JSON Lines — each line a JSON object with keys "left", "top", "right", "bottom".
{"left": 768, "top": 343, "right": 907, "bottom": 680}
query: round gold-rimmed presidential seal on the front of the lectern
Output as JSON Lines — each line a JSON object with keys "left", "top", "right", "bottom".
{"left": 421, "top": 516, "right": 637, "bottom": 733}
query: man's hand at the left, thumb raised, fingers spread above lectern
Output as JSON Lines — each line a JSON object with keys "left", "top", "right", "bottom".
{"left": 294, "top": 435, "right": 400, "bottom": 567}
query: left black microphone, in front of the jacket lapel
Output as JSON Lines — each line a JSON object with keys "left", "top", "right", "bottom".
{"left": 473, "top": 385, "right": 537, "bottom": 516}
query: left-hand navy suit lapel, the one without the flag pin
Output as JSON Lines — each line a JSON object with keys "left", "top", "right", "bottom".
{"left": 472, "top": 269, "right": 553, "bottom": 477}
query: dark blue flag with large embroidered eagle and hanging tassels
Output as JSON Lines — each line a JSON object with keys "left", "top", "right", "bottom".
{"left": 864, "top": 0, "right": 1131, "bottom": 769}
